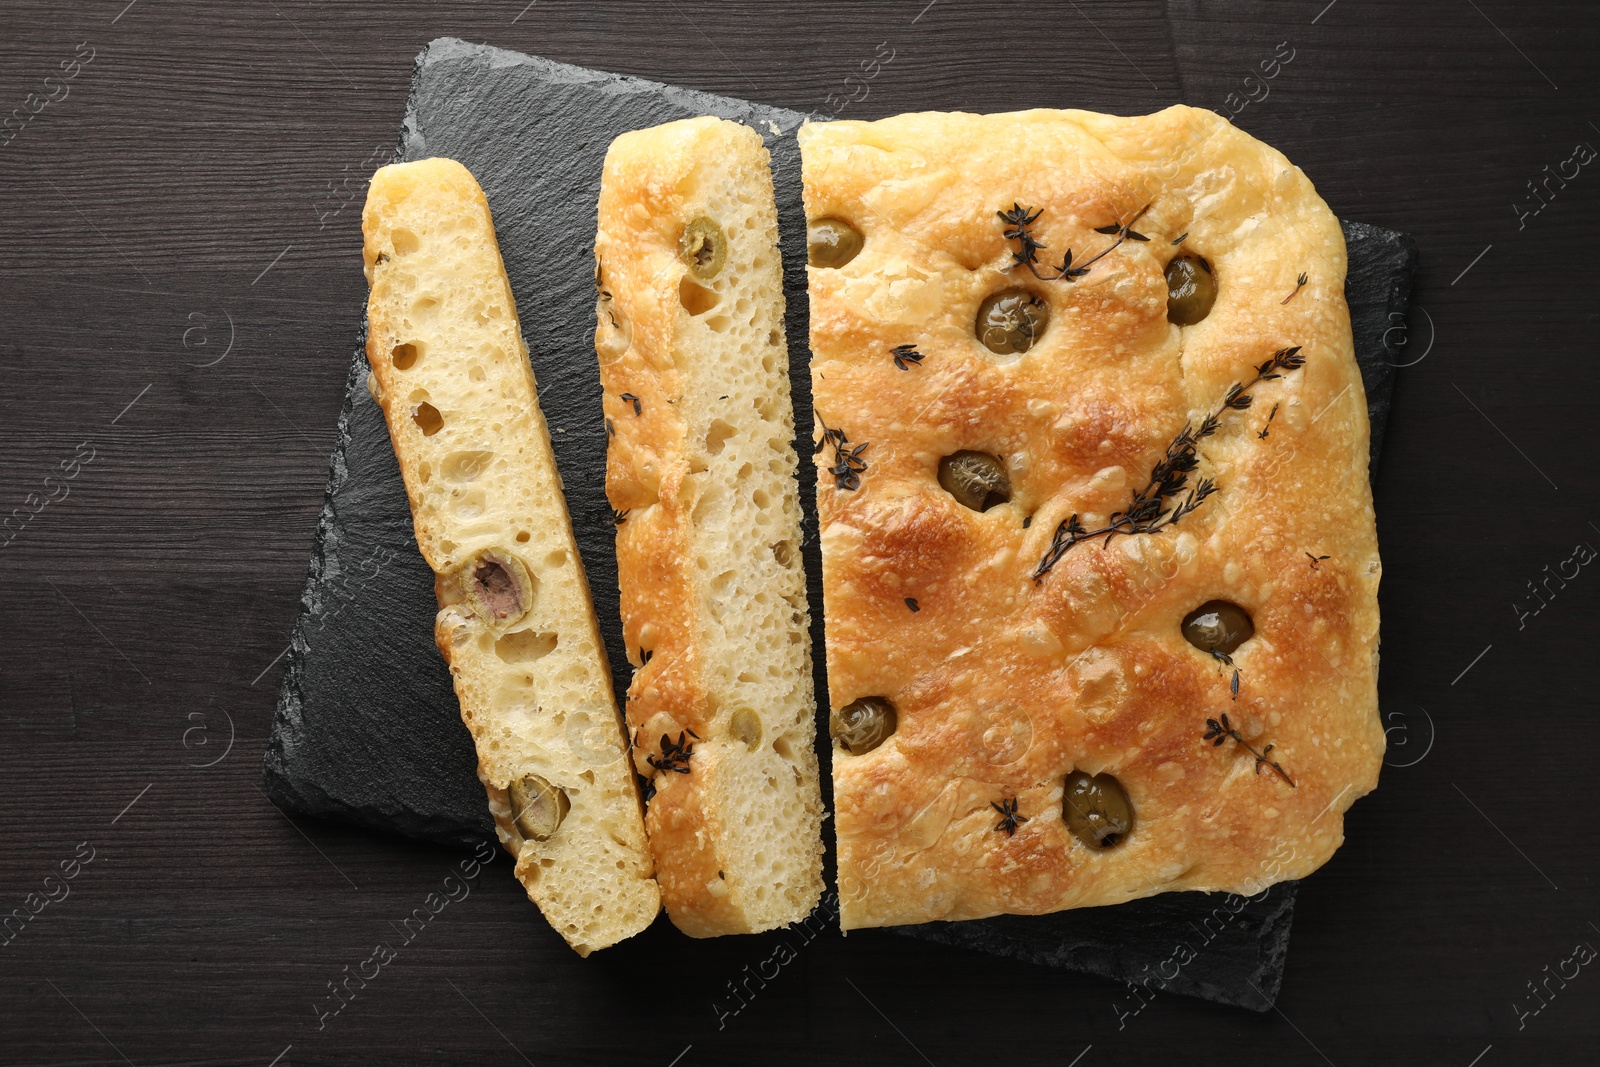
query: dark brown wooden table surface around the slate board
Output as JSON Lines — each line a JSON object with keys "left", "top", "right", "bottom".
{"left": 0, "top": 0, "right": 1600, "bottom": 1067}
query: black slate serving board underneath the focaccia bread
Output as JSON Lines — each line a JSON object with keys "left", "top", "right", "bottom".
{"left": 266, "top": 38, "right": 1416, "bottom": 1011}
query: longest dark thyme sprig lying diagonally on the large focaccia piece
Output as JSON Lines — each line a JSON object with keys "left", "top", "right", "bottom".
{"left": 1034, "top": 344, "right": 1306, "bottom": 582}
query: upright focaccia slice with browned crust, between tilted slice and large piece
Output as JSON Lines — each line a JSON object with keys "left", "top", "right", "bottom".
{"left": 595, "top": 117, "right": 822, "bottom": 937}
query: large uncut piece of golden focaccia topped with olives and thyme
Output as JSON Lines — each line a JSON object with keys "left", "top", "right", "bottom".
{"left": 800, "top": 107, "right": 1384, "bottom": 929}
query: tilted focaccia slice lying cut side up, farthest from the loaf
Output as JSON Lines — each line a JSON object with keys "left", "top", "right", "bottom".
{"left": 362, "top": 158, "right": 661, "bottom": 955}
